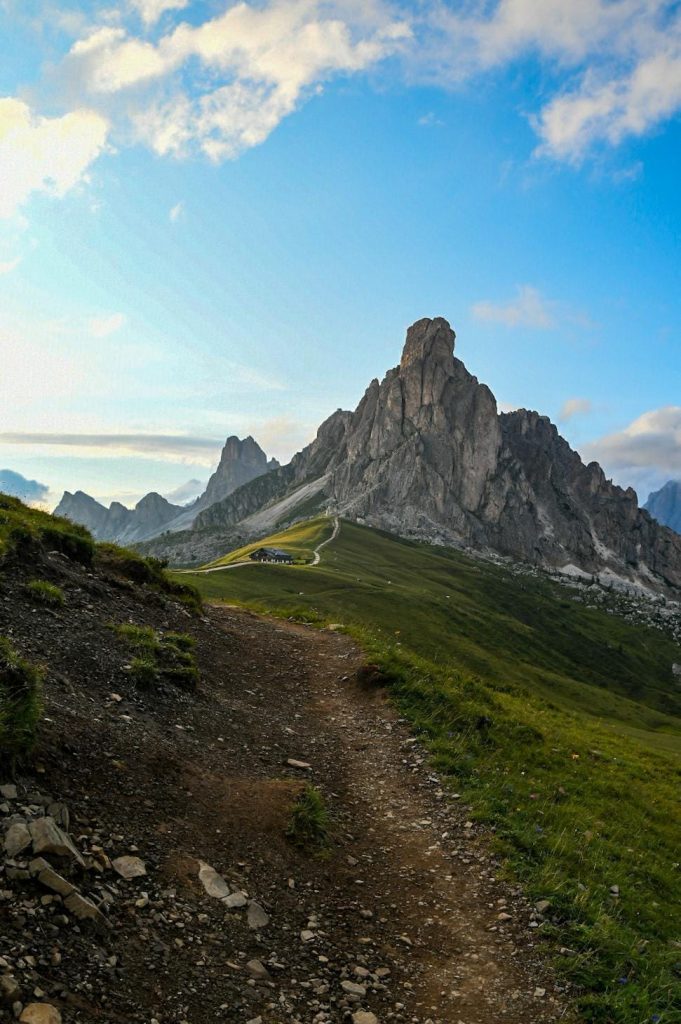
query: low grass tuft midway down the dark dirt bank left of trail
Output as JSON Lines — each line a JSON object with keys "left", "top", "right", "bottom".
{"left": 113, "top": 623, "right": 200, "bottom": 690}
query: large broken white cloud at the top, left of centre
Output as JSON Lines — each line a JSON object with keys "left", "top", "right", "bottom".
{"left": 62, "top": 0, "right": 410, "bottom": 161}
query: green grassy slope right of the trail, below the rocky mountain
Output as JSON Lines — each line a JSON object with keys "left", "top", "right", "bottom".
{"left": 182, "top": 523, "right": 681, "bottom": 1024}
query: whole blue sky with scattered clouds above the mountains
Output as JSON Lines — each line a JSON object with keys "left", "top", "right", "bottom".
{"left": 0, "top": 0, "right": 681, "bottom": 503}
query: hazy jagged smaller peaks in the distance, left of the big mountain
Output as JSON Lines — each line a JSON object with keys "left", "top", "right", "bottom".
{"left": 54, "top": 436, "right": 279, "bottom": 544}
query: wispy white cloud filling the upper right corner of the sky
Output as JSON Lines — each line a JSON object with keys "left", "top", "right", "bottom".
{"left": 414, "top": 0, "right": 681, "bottom": 163}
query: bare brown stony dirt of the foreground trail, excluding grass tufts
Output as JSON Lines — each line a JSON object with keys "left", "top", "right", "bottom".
{"left": 0, "top": 583, "right": 564, "bottom": 1024}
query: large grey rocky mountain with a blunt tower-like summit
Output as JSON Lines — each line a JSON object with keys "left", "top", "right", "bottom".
{"left": 137, "top": 318, "right": 681, "bottom": 587}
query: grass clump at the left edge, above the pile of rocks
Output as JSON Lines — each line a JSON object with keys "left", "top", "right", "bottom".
{"left": 0, "top": 637, "right": 44, "bottom": 765}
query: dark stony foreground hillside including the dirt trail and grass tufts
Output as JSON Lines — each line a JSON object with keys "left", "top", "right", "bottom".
{"left": 0, "top": 497, "right": 565, "bottom": 1024}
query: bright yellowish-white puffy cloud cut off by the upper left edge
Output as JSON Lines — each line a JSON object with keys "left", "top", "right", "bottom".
{"left": 0, "top": 97, "right": 109, "bottom": 219}
